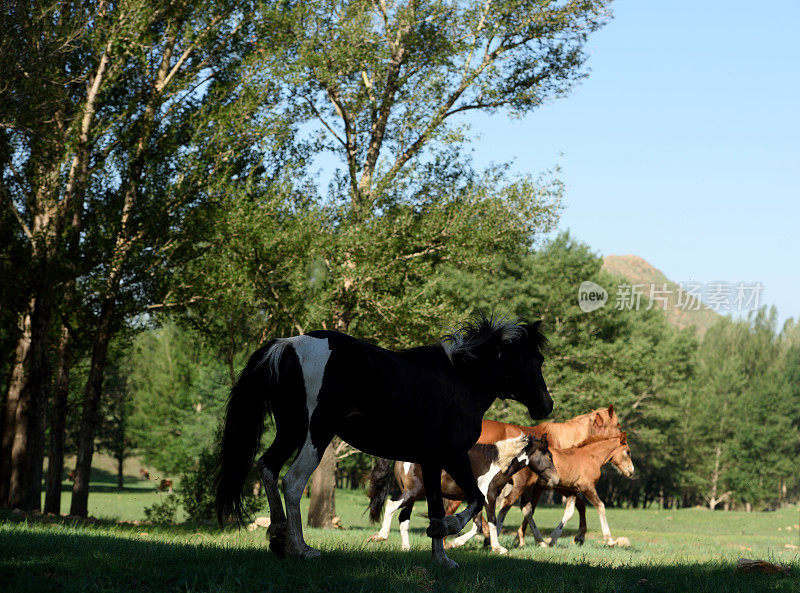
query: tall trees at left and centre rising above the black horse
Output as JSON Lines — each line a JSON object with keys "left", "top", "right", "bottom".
{"left": 0, "top": 0, "right": 609, "bottom": 520}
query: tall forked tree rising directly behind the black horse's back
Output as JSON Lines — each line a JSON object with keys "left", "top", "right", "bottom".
{"left": 260, "top": 0, "right": 608, "bottom": 526}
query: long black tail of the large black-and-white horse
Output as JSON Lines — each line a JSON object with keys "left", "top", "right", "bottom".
{"left": 217, "top": 341, "right": 282, "bottom": 525}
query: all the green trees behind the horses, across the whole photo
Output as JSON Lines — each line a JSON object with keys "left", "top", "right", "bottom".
{"left": 0, "top": 0, "right": 800, "bottom": 526}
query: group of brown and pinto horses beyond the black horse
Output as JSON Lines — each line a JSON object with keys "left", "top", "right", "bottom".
{"left": 368, "top": 405, "right": 633, "bottom": 554}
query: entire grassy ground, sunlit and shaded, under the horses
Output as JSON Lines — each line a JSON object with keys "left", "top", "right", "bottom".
{"left": 0, "top": 462, "right": 800, "bottom": 593}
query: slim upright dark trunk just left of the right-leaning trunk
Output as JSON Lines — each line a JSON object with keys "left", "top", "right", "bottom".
{"left": 44, "top": 325, "right": 72, "bottom": 515}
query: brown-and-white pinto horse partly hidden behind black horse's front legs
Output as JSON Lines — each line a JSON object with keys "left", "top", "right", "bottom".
{"left": 368, "top": 435, "right": 558, "bottom": 550}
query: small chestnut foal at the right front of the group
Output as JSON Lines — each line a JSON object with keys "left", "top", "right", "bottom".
{"left": 510, "top": 432, "right": 633, "bottom": 547}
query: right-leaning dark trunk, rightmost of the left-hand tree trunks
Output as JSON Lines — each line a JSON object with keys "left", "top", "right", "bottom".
{"left": 69, "top": 294, "right": 119, "bottom": 517}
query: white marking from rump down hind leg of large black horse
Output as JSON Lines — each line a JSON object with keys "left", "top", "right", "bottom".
{"left": 283, "top": 336, "right": 331, "bottom": 557}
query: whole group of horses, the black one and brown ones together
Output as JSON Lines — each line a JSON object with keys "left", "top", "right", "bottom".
{"left": 217, "top": 316, "right": 633, "bottom": 567}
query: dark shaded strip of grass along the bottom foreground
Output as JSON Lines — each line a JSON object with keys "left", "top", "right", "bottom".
{"left": 0, "top": 521, "right": 800, "bottom": 593}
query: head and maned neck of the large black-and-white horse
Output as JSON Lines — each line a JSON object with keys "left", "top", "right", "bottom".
{"left": 444, "top": 316, "right": 553, "bottom": 420}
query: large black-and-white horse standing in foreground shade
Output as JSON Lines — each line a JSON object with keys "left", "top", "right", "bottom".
{"left": 212, "top": 316, "right": 553, "bottom": 567}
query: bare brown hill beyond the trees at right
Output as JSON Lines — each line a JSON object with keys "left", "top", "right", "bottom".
{"left": 603, "top": 255, "right": 719, "bottom": 336}
